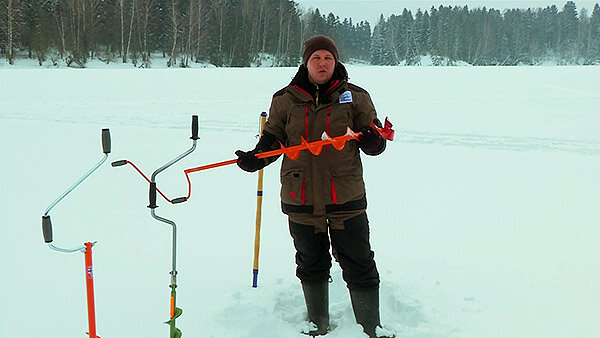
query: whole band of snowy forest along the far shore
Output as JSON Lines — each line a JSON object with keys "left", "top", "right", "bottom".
{"left": 0, "top": 0, "right": 600, "bottom": 67}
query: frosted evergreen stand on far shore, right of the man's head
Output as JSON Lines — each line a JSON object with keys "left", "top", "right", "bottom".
{"left": 371, "top": 1, "right": 600, "bottom": 65}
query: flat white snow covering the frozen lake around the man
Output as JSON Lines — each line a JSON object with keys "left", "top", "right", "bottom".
{"left": 0, "top": 67, "right": 600, "bottom": 338}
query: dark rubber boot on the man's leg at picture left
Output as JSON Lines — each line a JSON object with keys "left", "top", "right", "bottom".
{"left": 302, "top": 281, "right": 329, "bottom": 337}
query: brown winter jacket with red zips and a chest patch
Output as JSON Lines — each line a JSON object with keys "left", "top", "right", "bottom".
{"left": 264, "top": 64, "right": 386, "bottom": 215}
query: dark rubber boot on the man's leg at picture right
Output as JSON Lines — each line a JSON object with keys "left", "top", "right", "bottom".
{"left": 350, "top": 289, "right": 393, "bottom": 338}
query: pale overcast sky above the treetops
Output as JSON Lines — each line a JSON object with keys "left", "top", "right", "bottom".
{"left": 296, "top": 0, "right": 600, "bottom": 27}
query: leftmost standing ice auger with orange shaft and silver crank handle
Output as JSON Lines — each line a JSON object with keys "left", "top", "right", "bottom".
{"left": 42, "top": 129, "right": 110, "bottom": 338}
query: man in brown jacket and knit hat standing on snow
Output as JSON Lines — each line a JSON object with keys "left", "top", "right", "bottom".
{"left": 236, "top": 35, "right": 386, "bottom": 337}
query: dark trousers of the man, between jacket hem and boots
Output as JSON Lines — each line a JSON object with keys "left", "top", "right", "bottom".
{"left": 289, "top": 213, "right": 379, "bottom": 290}
